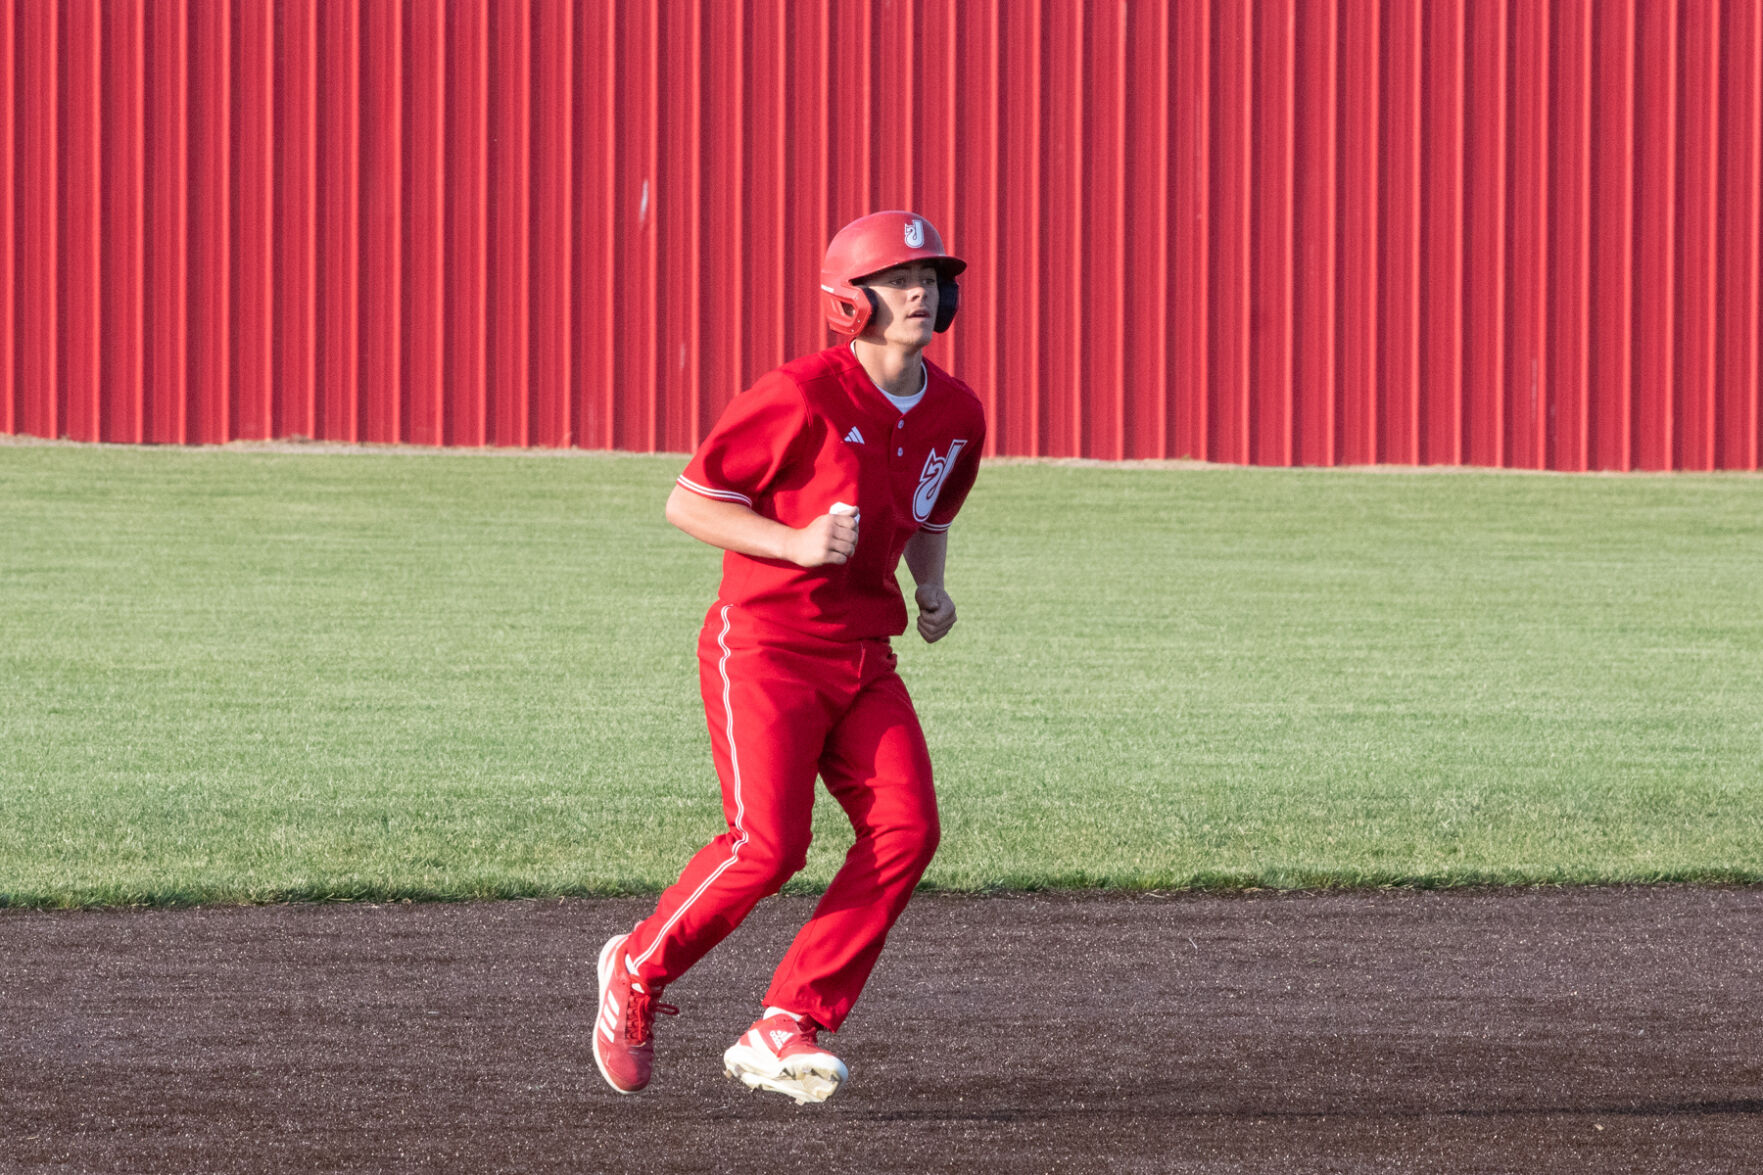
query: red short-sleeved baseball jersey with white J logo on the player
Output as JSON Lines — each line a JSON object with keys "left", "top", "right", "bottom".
{"left": 679, "top": 346, "right": 986, "bottom": 640}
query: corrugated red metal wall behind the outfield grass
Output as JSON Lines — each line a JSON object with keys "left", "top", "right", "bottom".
{"left": 0, "top": 0, "right": 1763, "bottom": 469}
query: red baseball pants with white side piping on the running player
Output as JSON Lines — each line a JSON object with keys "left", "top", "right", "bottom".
{"left": 628, "top": 602, "right": 938, "bottom": 1030}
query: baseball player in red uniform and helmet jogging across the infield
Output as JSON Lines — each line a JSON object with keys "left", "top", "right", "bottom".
{"left": 594, "top": 212, "right": 986, "bottom": 1104}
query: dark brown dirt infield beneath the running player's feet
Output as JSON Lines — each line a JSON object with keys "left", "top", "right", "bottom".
{"left": 0, "top": 887, "right": 1763, "bottom": 1175}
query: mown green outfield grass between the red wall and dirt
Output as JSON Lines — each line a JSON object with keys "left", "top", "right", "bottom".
{"left": 0, "top": 445, "right": 1763, "bottom": 905}
